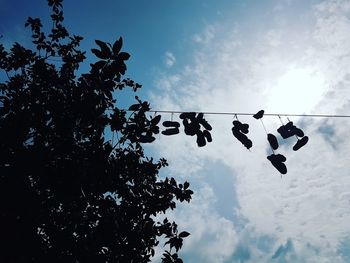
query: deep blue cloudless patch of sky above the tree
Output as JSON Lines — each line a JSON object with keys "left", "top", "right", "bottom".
{"left": 0, "top": 0, "right": 246, "bottom": 92}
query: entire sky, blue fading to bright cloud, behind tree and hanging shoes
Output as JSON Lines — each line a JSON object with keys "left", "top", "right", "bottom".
{"left": 0, "top": 0, "right": 350, "bottom": 263}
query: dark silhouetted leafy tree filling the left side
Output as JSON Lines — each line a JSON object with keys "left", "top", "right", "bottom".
{"left": 0, "top": 0, "right": 193, "bottom": 263}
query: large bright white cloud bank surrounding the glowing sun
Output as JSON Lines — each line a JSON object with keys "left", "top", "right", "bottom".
{"left": 152, "top": 1, "right": 350, "bottom": 262}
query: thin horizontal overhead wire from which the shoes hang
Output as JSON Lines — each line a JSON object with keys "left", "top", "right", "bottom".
{"left": 139, "top": 110, "right": 350, "bottom": 118}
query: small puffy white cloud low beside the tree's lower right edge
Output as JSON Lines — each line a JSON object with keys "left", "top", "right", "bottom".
{"left": 176, "top": 186, "right": 237, "bottom": 263}
